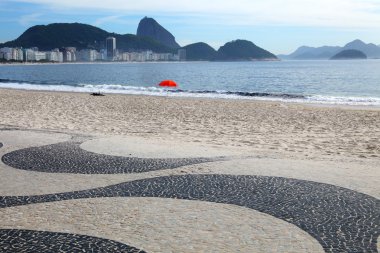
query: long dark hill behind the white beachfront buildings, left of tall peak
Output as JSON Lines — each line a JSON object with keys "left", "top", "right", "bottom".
{"left": 0, "top": 23, "right": 173, "bottom": 52}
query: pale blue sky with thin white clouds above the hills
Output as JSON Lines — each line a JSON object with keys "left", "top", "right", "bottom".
{"left": 0, "top": 0, "right": 380, "bottom": 54}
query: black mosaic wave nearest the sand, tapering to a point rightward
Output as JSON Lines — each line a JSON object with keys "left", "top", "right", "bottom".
{"left": 2, "top": 141, "right": 223, "bottom": 174}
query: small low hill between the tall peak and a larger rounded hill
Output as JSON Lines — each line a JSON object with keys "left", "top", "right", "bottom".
{"left": 183, "top": 42, "right": 217, "bottom": 61}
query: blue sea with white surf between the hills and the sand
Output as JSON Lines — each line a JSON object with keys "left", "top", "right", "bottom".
{"left": 0, "top": 60, "right": 380, "bottom": 107}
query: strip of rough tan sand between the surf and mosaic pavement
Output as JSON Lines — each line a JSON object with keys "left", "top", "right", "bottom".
{"left": 0, "top": 89, "right": 380, "bottom": 162}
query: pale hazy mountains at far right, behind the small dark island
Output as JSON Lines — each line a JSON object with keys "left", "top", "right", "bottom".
{"left": 279, "top": 40, "right": 380, "bottom": 60}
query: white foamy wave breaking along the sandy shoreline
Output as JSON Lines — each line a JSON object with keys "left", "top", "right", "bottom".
{"left": 0, "top": 79, "right": 380, "bottom": 107}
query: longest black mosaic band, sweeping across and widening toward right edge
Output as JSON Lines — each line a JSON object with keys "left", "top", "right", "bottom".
{"left": 0, "top": 175, "right": 380, "bottom": 252}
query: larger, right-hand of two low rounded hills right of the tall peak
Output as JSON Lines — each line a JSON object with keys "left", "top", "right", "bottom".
{"left": 217, "top": 40, "right": 277, "bottom": 61}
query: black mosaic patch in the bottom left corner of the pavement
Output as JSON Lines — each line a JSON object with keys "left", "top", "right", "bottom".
{"left": 0, "top": 229, "right": 145, "bottom": 253}
